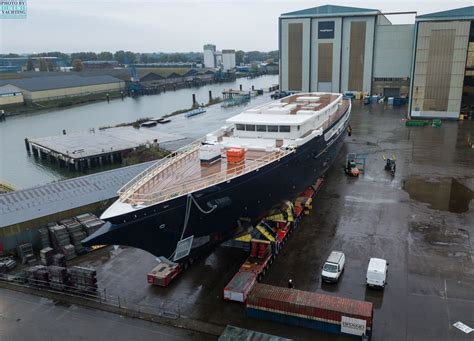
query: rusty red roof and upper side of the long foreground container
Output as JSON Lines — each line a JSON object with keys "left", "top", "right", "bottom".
{"left": 247, "top": 283, "right": 373, "bottom": 335}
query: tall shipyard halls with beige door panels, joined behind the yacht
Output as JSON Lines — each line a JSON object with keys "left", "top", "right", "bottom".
{"left": 279, "top": 5, "right": 474, "bottom": 118}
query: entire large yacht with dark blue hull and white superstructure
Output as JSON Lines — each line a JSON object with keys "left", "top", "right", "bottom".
{"left": 83, "top": 92, "right": 351, "bottom": 259}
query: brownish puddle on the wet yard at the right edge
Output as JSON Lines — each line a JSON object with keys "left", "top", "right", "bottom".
{"left": 403, "top": 177, "right": 474, "bottom": 213}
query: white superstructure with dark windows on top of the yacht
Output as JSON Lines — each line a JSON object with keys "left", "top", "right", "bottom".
{"left": 206, "top": 93, "right": 345, "bottom": 150}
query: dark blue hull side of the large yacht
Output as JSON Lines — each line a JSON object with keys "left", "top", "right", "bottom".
{"left": 83, "top": 106, "right": 350, "bottom": 257}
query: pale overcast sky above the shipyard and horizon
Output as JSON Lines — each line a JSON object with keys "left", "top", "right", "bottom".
{"left": 0, "top": 0, "right": 473, "bottom": 53}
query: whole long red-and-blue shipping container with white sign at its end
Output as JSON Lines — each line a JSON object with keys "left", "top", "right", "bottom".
{"left": 247, "top": 283, "right": 373, "bottom": 337}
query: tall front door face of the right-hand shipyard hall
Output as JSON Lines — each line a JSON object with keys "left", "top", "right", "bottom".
{"left": 411, "top": 21, "right": 470, "bottom": 118}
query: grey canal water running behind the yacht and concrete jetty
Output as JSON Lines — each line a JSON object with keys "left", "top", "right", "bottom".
{"left": 0, "top": 75, "right": 278, "bottom": 189}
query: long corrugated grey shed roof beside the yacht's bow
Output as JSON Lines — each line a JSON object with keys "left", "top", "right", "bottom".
{"left": 0, "top": 161, "right": 154, "bottom": 228}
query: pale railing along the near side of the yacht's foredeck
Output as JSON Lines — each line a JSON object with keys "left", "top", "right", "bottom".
{"left": 120, "top": 147, "right": 295, "bottom": 206}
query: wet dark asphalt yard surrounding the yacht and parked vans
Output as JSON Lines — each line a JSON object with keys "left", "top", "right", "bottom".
{"left": 4, "top": 101, "right": 474, "bottom": 341}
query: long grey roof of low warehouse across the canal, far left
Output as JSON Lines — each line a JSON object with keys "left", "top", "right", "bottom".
{"left": 0, "top": 75, "right": 122, "bottom": 91}
